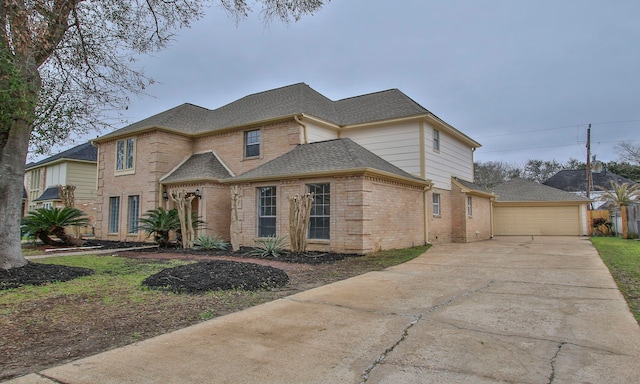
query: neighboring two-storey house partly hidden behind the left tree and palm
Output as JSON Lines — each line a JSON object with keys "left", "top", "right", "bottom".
{"left": 24, "top": 143, "right": 98, "bottom": 235}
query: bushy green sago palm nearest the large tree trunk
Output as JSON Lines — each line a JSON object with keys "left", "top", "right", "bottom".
{"left": 22, "top": 207, "right": 89, "bottom": 246}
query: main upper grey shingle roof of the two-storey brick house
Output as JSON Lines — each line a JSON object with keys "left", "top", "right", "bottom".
{"left": 100, "top": 83, "right": 430, "bottom": 139}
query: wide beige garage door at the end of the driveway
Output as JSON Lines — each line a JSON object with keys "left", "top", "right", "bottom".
{"left": 493, "top": 205, "right": 581, "bottom": 236}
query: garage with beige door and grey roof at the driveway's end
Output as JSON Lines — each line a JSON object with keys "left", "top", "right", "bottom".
{"left": 491, "top": 179, "right": 592, "bottom": 236}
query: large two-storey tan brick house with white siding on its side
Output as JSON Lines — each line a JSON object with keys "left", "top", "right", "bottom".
{"left": 94, "top": 83, "right": 491, "bottom": 253}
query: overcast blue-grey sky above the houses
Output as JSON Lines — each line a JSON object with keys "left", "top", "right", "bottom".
{"left": 48, "top": 0, "right": 640, "bottom": 164}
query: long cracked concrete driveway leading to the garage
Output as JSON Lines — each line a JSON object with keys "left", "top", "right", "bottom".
{"left": 13, "top": 237, "right": 640, "bottom": 384}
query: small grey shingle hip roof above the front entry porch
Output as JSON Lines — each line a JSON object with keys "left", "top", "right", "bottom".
{"left": 160, "top": 152, "right": 231, "bottom": 183}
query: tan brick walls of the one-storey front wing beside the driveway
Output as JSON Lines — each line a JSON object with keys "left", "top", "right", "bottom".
{"left": 229, "top": 175, "right": 425, "bottom": 253}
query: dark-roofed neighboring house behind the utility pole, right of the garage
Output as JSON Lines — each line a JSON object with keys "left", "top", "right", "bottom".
{"left": 544, "top": 169, "right": 636, "bottom": 209}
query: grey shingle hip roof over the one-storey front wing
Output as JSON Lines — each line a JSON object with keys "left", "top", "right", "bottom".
{"left": 232, "top": 138, "right": 425, "bottom": 182}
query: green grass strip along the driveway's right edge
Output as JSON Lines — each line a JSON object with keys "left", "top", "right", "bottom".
{"left": 591, "top": 237, "right": 640, "bottom": 323}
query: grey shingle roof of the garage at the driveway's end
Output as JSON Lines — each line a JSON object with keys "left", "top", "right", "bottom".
{"left": 491, "top": 179, "right": 591, "bottom": 203}
